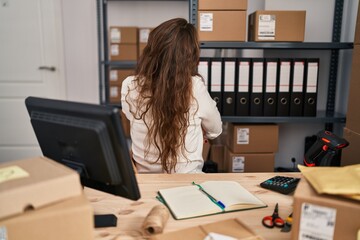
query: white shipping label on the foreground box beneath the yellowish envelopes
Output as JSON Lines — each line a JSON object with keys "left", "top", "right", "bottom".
{"left": 299, "top": 202, "right": 336, "bottom": 240}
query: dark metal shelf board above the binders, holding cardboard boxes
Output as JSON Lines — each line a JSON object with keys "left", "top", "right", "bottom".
{"left": 200, "top": 42, "right": 354, "bottom": 50}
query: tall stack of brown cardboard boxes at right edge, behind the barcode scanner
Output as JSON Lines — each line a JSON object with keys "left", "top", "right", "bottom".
{"left": 341, "top": 5, "right": 360, "bottom": 166}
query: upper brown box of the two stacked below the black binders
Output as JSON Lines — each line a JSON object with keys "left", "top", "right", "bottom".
{"left": 226, "top": 123, "right": 279, "bottom": 153}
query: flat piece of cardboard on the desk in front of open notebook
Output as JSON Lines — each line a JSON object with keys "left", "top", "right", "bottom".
{"left": 150, "top": 219, "right": 263, "bottom": 240}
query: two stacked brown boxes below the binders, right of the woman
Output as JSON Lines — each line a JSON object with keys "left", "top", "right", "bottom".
{"left": 224, "top": 123, "right": 279, "bottom": 172}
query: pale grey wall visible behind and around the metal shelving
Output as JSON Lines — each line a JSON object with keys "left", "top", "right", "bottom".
{"left": 62, "top": 0, "right": 359, "bottom": 167}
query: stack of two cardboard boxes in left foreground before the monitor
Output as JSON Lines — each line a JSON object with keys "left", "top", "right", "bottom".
{"left": 0, "top": 157, "right": 94, "bottom": 240}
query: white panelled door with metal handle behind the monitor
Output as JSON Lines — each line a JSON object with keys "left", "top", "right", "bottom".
{"left": 0, "top": 0, "right": 66, "bottom": 162}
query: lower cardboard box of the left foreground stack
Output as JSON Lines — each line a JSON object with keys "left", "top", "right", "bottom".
{"left": 0, "top": 195, "right": 94, "bottom": 240}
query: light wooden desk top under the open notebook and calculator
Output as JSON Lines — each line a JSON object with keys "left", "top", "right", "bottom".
{"left": 85, "top": 173, "right": 301, "bottom": 240}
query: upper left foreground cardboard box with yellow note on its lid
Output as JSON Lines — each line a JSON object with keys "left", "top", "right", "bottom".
{"left": 0, "top": 157, "right": 82, "bottom": 220}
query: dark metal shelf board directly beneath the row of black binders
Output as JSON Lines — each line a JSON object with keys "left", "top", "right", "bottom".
{"left": 222, "top": 111, "right": 346, "bottom": 123}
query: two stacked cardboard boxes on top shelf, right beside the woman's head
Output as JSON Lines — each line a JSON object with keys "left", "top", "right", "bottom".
{"left": 197, "top": 0, "right": 247, "bottom": 42}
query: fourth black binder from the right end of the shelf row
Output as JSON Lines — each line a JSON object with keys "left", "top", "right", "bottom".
{"left": 264, "top": 58, "right": 278, "bottom": 116}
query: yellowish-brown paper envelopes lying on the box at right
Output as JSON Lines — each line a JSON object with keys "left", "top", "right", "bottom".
{"left": 298, "top": 164, "right": 360, "bottom": 201}
